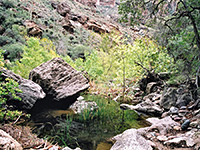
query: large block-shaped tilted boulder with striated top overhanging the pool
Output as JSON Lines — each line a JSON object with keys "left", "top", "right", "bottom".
{"left": 29, "top": 58, "right": 89, "bottom": 108}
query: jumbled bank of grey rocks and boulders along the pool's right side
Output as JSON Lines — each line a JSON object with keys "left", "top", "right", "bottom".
{"left": 117, "top": 72, "right": 200, "bottom": 150}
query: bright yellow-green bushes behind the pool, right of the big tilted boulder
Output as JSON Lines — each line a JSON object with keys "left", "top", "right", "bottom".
{"left": 68, "top": 35, "right": 173, "bottom": 85}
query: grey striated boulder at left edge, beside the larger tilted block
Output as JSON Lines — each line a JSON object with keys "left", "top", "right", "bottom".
{"left": 0, "top": 69, "right": 46, "bottom": 110}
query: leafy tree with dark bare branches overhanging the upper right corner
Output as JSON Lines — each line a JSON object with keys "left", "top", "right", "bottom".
{"left": 119, "top": 0, "right": 200, "bottom": 74}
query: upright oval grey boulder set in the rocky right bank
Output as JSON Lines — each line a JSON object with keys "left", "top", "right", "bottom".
{"left": 160, "top": 88, "right": 177, "bottom": 110}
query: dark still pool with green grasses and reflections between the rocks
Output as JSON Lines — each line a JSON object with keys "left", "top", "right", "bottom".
{"left": 29, "top": 95, "right": 148, "bottom": 150}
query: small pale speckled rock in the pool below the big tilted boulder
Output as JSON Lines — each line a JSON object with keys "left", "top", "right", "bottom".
{"left": 70, "top": 97, "right": 98, "bottom": 114}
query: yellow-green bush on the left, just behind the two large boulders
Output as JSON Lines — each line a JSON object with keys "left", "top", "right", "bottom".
{"left": 11, "top": 38, "right": 58, "bottom": 78}
